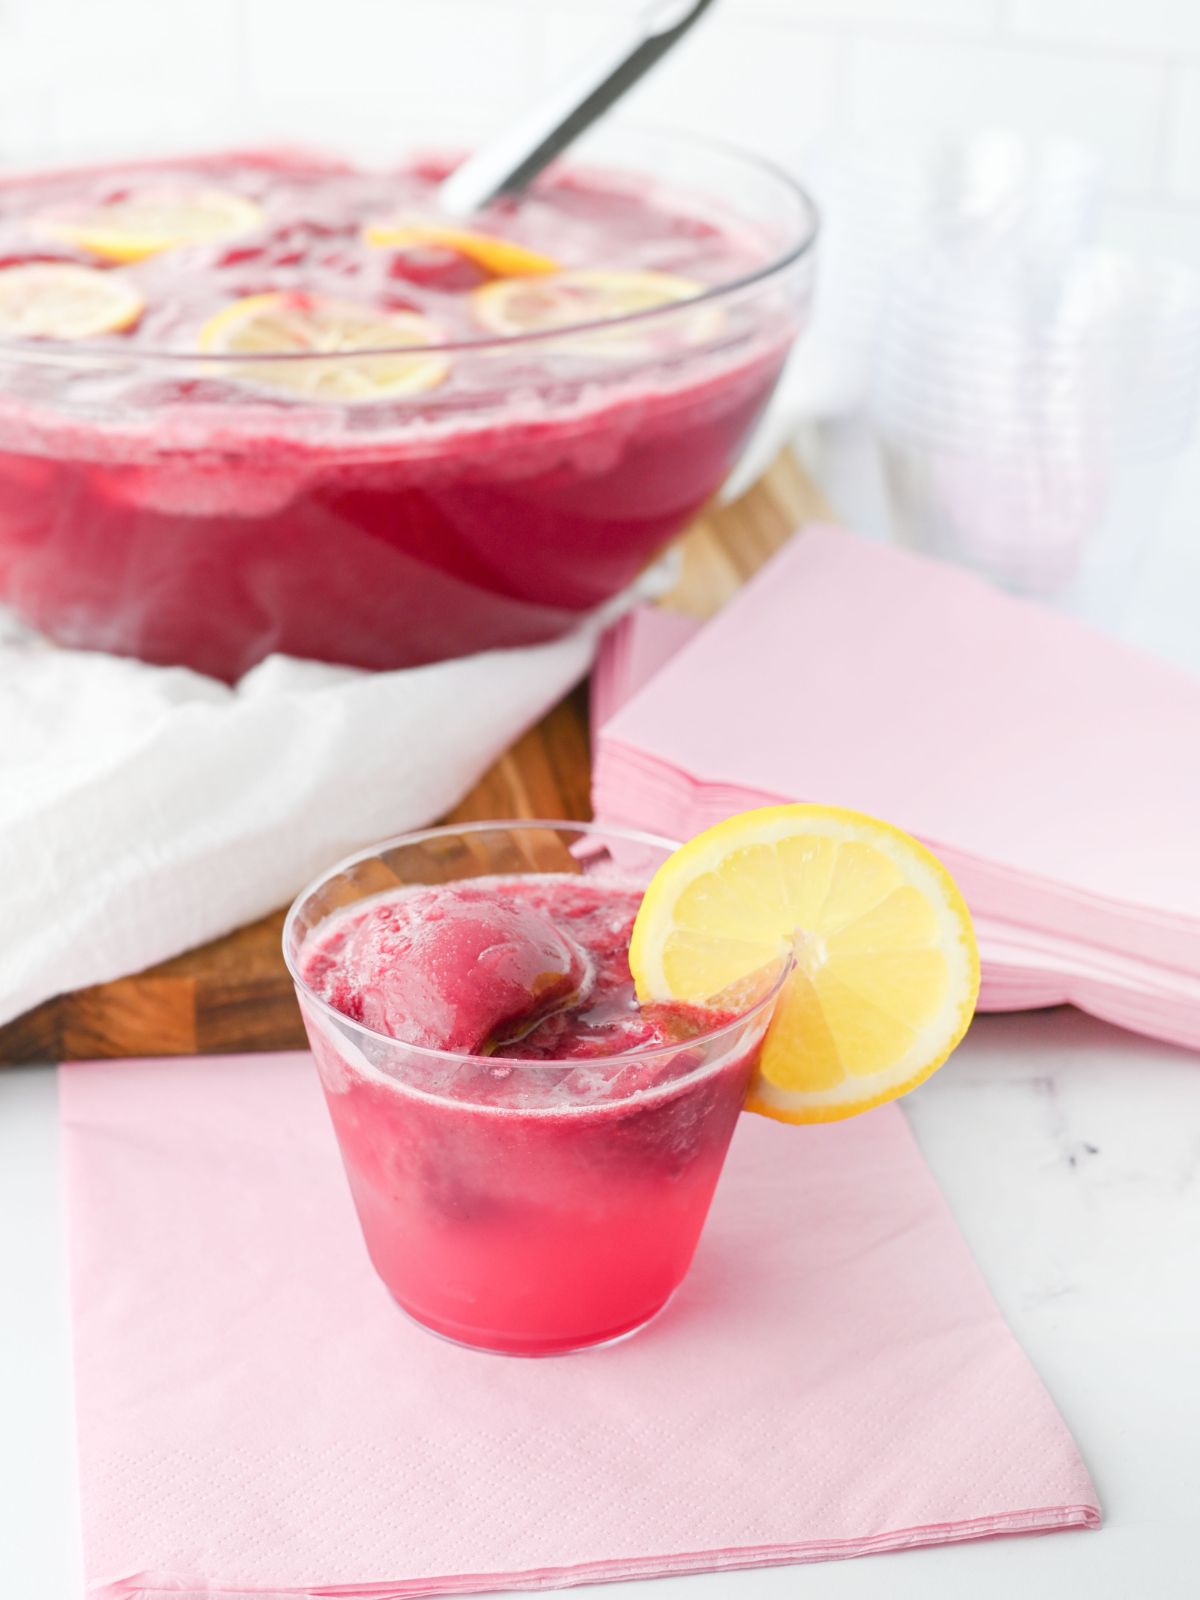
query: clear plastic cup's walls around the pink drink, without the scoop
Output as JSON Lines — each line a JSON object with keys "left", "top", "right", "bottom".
{"left": 283, "top": 822, "right": 784, "bottom": 1355}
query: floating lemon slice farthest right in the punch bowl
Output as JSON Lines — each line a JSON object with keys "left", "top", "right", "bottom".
{"left": 470, "top": 269, "right": 720, "bottom": 354}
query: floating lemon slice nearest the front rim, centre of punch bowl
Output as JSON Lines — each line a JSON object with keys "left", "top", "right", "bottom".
{"left": 198, "top": 293, "right": 450, "bottom": 402}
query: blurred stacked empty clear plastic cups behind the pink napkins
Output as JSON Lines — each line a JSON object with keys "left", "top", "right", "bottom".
{"left": 874, "top": 136, "right": 1200, "bottom": 622}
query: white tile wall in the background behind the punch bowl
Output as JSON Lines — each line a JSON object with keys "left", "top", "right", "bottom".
{"left": 0, "top": 0, "right": 1200, "bottom": 252}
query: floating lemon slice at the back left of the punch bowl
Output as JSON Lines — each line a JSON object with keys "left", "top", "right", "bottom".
{"left": 38, "top": 189, "right": 262, "bottom": 261}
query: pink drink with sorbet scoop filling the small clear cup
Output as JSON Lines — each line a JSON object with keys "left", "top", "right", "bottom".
{"left": 285, "top": 822, "right": 774, "bottom": 1355}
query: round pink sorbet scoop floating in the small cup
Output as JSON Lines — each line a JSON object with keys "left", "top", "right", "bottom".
{"left": 328, "top": 888, "right": 590, "bottom": 1053}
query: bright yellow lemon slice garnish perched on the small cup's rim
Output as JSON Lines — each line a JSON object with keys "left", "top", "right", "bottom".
{"left": 629, "top": 805, "right": 979, "bottom": 1122}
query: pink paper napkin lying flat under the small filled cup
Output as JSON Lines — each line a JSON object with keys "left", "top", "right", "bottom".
{"left": 59, "top": 1056, "right": 1099, "bottom": 1600}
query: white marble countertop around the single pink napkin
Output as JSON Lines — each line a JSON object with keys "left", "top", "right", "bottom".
{"left": 0, "top": 1011, "right": 1200, "bottom": 1600}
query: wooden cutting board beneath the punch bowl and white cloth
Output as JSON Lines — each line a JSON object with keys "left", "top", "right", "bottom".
{"left": 0, "top": 453, "right": 829, "bottom": 1064}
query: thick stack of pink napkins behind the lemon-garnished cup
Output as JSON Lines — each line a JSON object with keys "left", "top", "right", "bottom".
{"left": 594, "top": 526, "right": 1200, "bottom": 1048}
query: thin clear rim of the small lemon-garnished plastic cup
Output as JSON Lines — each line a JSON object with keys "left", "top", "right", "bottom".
{"left": 282, "top": 818, "right": 792, "bottom": 1083}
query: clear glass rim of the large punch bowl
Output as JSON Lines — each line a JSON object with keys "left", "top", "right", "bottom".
{"left": 0, "top": 122, "right": 821, "bottom": 374}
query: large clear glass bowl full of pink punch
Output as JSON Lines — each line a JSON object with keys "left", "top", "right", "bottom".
{"left": 0, "top": 138, "right": 814, "bottom": 680}
